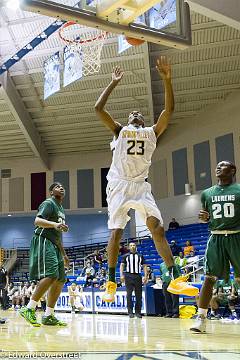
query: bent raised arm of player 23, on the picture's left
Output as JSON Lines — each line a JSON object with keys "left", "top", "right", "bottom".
{"left": 95, "top": 66, "right": 123, "bottom": 136}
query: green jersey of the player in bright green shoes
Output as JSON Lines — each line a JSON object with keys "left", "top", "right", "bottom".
{"left": 35, "top": 198, "right": 65, "bottom": 245}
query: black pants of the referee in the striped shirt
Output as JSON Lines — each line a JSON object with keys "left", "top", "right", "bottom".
{"left": 125, "top": 273, "right": 142, "bottom": 314}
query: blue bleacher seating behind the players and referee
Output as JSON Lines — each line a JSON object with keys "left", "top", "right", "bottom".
{"left": 11, "top": 224, "right": 209, "bottom": 281}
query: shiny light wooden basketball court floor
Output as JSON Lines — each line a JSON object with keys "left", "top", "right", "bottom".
{"left": 0, "top": 310, "right": 240, "bottom": 360}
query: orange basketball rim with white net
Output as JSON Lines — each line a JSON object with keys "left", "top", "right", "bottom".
{"left": 59, "top": 21, "right": 107, "bottom": 76}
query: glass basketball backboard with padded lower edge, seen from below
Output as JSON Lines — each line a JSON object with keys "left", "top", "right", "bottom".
{"left": 21, "top": 0, "right": 191, "bottom": 49}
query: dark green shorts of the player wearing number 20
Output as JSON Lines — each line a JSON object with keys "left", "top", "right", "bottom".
{"left": 205, "top": 233, "right": 240, "bottom": 281}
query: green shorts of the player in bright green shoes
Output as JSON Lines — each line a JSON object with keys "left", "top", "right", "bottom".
{"left": 29, "top": 235, "right": 66, "bottom": 282}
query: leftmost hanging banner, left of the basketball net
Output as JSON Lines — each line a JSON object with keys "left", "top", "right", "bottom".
{"left": 43, "top": 51, "right": 60, "bottom": 100}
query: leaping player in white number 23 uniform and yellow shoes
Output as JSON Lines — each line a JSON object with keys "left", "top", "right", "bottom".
{"left": 95, "top": 57, "right": 198, "bottom": 302}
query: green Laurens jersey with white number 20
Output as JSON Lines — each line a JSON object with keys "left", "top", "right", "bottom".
{"left": 201, "top": 183, "right": 240, "bottom": 230}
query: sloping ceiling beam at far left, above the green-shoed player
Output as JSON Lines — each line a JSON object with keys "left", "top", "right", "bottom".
{"left": 0, "top": 72, "right": 49, "bottom": 168}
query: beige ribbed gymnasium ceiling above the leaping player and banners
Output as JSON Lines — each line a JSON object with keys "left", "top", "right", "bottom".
{"left": 0, "top": 0, "right": 240, "bottom": 169}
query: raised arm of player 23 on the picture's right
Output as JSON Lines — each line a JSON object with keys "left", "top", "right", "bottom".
{"left": 153, "top": 56, "right": 174, "bottom": 138}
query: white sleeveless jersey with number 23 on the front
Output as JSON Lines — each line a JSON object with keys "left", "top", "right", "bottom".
{"left": 107, "top": 125, "right": 157, "bottom": 181}
